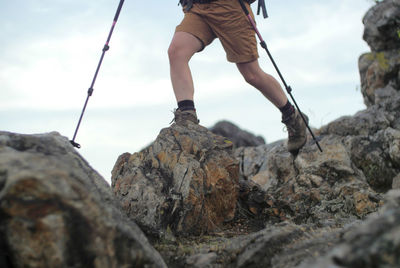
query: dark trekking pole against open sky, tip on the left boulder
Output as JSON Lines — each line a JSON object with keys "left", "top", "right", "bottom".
{"left": 70, "top": 0, "right": 125, "bottom": 149}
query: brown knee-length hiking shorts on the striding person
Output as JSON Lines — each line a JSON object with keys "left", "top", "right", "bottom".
{"left": 176, "top": 0, "right": 258, "bottom": 63}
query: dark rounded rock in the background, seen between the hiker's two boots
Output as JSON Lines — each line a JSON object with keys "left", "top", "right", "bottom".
{"left": 210, "top": 121, "right": 265, "bottom": 147}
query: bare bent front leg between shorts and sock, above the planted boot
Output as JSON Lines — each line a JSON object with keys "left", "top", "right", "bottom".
{"left": 168, "top": 32, "right": 203, "bottom": 102}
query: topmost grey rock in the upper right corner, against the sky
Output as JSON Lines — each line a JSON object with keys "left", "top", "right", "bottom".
{"left": 363, "top": 0, "right": 400, "bottom": 51}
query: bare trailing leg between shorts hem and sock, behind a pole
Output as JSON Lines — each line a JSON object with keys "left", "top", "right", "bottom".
{"left": 236, "top": 60, "right": 288, "bottom": 108}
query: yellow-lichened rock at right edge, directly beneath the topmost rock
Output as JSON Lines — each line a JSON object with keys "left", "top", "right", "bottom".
{"left": 358, "top": 49, "right": 400, "bottom": 106}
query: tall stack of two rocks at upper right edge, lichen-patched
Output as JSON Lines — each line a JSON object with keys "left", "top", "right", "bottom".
{"left": 359, "top": 0, "right": 400, "bottom": 106}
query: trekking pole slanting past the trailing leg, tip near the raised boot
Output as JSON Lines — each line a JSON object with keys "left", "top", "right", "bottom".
{"left": 238, "top": 0, "right": 322, "bottom": 152}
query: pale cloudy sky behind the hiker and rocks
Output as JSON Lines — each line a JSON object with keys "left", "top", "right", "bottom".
{"left": 0, "top": 0, "right": 373, "bottom": 181}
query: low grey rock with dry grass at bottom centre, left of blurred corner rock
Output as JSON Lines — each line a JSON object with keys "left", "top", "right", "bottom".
{"left": 156, "top": 222, "right": 342, "bottom": 268}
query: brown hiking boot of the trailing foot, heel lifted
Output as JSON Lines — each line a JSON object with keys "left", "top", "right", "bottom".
{"left": 282, "top": 110, "right": 308, "bottom": 155}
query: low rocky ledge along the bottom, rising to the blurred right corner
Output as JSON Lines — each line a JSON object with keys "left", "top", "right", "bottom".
{"left": 156, "top": 190, "right": 400, "bottom": 268}
